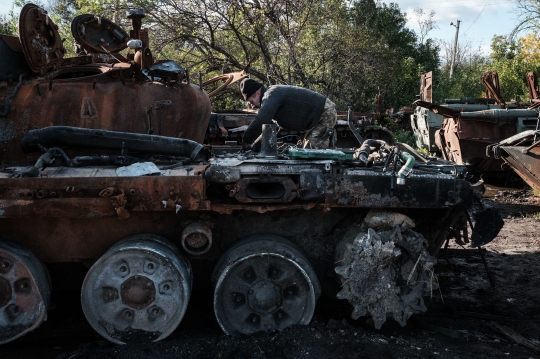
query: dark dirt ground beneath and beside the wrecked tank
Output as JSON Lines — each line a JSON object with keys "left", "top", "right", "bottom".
{"left": 0, "top": 186, "right": 540, "bottom": 359}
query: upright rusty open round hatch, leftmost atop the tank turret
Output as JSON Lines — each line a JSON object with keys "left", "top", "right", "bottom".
{"left": 19, "top": 4, "right": 66, "bottom": 75}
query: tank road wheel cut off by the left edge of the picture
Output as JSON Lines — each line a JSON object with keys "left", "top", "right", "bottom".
{"left": 0, "top": 240, "right": 51, "bottom": 344}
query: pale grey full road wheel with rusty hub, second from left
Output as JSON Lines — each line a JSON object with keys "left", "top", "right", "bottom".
{"left": 81, "top": 234, "right": 192, "bottom": 344}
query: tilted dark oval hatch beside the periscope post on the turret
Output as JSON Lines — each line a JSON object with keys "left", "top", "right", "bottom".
{"left": 71, "top": 14, "right": 129, "bottom": 54}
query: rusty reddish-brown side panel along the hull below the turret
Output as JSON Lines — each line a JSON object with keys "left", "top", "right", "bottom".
{"left": 0, "top": 176, "right": 210, "bottom": 219}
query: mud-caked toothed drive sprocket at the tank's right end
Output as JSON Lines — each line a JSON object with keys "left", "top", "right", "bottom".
{"left": 335, "top": 225, "right": 437, "bottom": 329}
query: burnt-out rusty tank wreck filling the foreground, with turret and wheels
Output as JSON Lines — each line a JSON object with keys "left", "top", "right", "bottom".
{"left": 0, "top": 5, "right": 501, "bottom": 344}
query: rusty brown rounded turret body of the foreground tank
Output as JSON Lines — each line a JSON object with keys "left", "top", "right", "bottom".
{"left": 0, "top": 71, "right": 211, "bottom": 164}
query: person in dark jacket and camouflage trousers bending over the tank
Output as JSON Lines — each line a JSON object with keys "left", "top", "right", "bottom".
{"left": 240, "top": 79, "right": 337, "bottom": 149}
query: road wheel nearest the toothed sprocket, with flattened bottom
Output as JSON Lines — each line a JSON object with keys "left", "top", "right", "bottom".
{"left": 212, "top": 235, "right": 321, "bottom": 335}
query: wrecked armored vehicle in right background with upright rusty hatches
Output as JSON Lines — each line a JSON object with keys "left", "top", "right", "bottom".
{"left": 411, "top": 72, "right": 538, "bottom": 177}
